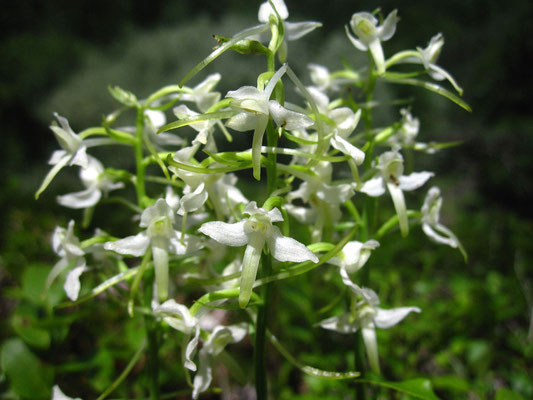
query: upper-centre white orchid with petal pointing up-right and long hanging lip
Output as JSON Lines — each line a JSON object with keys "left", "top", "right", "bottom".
{"left": 226, "top": 64, "right": 314, "bottom": 180}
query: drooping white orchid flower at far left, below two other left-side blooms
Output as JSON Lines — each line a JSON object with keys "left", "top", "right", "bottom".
{"left": 45, "top": 220, "right": 89, "bottom": 301}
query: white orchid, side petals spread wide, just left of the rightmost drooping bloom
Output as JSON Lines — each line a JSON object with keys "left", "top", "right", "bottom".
{"left": 359, "top": 148, "right": 434, "bottom": 236}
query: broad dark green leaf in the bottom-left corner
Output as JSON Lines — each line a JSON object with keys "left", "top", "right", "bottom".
{"left": 0, "top": 338, "right": 53, "bottom": 399}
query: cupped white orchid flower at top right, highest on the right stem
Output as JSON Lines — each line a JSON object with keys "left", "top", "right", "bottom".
{"left": 345, "top": 10, "right": 398, "bottom": 75}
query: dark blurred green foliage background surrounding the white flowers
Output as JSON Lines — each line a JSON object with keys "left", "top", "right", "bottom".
{"left": 0, "top": 0, "right": 533, "bottom": 400}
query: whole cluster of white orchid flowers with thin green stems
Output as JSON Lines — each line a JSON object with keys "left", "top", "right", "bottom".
{"left": 36, "top": 0, "right": 468, "bottom": 399}
